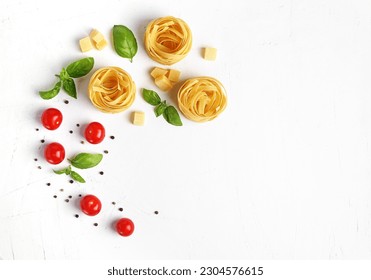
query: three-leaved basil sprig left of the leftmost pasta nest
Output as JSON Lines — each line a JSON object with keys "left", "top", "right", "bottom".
{"left": 39, "top": 57, "right": 94, "bottom": 99}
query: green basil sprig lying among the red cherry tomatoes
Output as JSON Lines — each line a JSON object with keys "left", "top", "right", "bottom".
{"left": 53, "top": 153, "right": 103, "bottom": 183}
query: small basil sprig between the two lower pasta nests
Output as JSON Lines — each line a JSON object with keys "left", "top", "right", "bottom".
{"left": 143, "top": 88, "right": 183, "bottom": 126}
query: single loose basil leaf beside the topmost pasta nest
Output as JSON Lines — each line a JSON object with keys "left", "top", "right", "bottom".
{"left": 112, "top": 25, "right": 138, "bottom": 62}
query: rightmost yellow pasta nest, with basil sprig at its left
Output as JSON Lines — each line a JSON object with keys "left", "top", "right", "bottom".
{"left": 178, "top": 77, "right": 227, "bottom": 122}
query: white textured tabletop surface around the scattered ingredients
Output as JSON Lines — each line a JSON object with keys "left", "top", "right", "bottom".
{"left": 0, "top": 0, "right": 371, "bottom": 259}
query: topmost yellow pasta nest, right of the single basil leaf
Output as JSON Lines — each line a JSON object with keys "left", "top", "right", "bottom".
{"left": 144, "top": 16, "right": 192, "bottom": 65}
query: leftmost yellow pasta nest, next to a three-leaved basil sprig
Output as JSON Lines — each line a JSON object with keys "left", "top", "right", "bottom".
{"left": 88, "top": 66, "right": 136, "bottom": 113}
